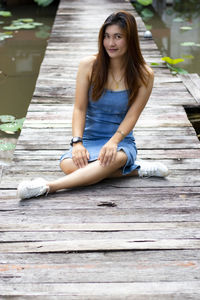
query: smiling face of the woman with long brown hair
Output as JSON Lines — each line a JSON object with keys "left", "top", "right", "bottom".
{"left": 103, "top": 24, "right": 127, "bottom": 58}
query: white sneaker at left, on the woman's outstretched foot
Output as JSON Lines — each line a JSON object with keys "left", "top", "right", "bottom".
{"left": 17, "top": 178, "right": 49, "bottom": 200}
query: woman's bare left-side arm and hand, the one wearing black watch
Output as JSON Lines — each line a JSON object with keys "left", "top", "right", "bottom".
{"left": 72, "top": 56, "right": 95, "bottom": 168}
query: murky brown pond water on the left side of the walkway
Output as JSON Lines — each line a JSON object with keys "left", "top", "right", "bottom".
{"left": 0, "top": 1, "right": 58, "bottom": 163}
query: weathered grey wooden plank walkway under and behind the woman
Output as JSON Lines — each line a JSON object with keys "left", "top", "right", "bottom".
{"left": 0, "top": 0, "right": 200, "bottom": 300}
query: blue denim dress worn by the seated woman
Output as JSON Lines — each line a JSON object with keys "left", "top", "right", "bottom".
{"left": 60, "top": 89, "right": 140, "bottom": 175}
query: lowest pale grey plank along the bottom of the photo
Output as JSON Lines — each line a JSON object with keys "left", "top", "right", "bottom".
{"left": 0, "top": 280, "right": 200, "bottom": 300}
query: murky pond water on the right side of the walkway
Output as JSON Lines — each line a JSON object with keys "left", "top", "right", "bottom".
{"left": 133, "top": 0, "right": 200, "bottom": 75}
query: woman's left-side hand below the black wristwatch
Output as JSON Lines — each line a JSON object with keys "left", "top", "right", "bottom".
{"left": 72, "top": 143, "right": 89, "bottom": 168}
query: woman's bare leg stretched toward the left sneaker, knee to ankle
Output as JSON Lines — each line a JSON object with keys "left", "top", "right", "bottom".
{"left": 47, "top": 151, "right": 127, "bottom": 192}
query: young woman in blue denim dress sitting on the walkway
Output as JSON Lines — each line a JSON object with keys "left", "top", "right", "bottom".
{"left": 18, "top": 11, "right": 168, "bottom": 199}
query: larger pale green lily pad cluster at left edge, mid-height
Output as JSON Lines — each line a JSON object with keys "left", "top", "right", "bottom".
{"left": 0, "top": 115, "right": 25, "bottom": 134}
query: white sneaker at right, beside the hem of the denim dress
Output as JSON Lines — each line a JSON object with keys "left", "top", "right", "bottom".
{"left": 135, "top": 161, "right": 169, "bottom": 177}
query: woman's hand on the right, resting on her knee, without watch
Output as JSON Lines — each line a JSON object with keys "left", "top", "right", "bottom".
{"left": 98, "top": 141, "right": 117, "bottom": 167}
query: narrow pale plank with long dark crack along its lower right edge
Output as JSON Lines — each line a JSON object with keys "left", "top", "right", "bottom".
{"left": 0, "top": 239, "right": 200, "bottom": 253}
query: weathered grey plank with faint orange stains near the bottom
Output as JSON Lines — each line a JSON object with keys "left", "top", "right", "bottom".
{"left": 0, "top": 258, "right": 200, "bottom": 285}
